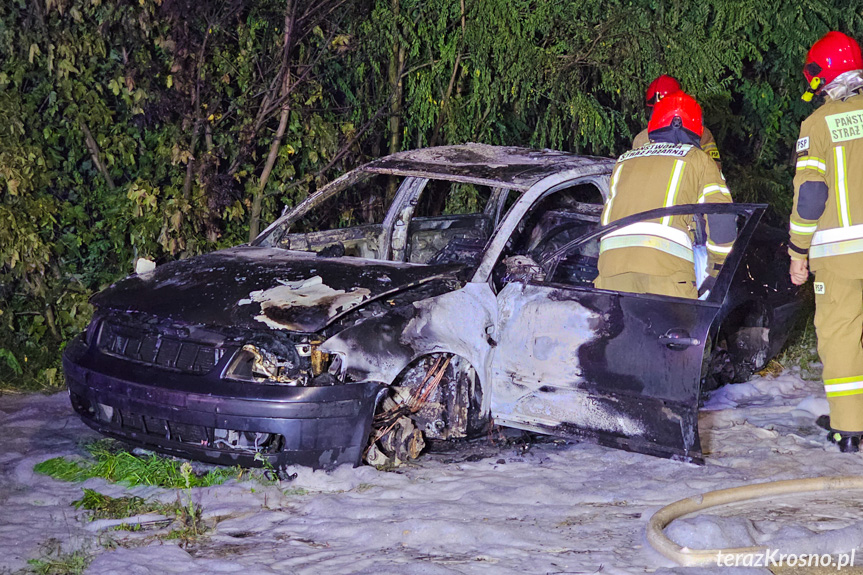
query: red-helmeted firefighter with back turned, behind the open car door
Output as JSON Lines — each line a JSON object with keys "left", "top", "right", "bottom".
{"left": 595, "top": 92, "right": 737, "bottom": 298}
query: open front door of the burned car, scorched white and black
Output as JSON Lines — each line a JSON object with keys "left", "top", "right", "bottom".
{"left": 491, "top": 204, "right": 765, "bottom": 463}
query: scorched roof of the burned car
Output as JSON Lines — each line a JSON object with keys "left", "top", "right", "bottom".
{"left": 361, "top": 143, "right": 615, "bottom": 191}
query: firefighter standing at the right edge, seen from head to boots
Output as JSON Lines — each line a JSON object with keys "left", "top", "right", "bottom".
{"left": 788, "top": 32, "right": 863, "bottom": 452}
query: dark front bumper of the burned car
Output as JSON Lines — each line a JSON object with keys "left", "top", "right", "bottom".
{"left": 63, "top": 337, "right": 383, "bottom": 468}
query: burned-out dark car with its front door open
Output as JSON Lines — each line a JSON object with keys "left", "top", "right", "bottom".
{"left": 63, "top": 144, "right": 799, "bottom": 467}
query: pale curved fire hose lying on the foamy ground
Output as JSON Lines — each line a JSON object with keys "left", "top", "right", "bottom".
{"left": 647, "top": 476, "right": 863, "bottom": 567}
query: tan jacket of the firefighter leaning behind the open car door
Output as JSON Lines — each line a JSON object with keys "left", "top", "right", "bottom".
{"left": 599, "top": 142, "right": 737, "bottom": 280}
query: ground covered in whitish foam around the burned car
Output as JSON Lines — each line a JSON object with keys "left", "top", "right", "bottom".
{"left": 0, "top": 372, "right": 863, "bottom": 575}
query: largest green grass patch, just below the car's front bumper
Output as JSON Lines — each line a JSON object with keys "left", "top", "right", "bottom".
{"left": 33, "top": 439, "right": 247, "bottom": 488}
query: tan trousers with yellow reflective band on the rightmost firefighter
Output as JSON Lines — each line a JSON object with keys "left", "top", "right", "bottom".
{"left": 815, "top": 270, "right": 863, "bottom": 433}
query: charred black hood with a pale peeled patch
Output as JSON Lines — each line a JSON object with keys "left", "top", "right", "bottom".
{"left": 91, "top": 246, "right": 461, "bottom": 333}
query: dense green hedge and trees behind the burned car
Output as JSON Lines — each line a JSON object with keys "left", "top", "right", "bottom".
{"left": 0, "top": 0, "right": 863, "bottom": 388}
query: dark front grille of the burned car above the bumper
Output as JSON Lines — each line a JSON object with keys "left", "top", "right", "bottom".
{"left": 98, "top": 322, "right": 224, "bottom": 374}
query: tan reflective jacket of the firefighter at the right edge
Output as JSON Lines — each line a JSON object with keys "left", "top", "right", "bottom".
{"left": 788, "top": 93, "right": 863, "bottom": 278}
